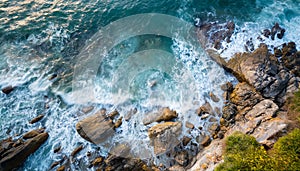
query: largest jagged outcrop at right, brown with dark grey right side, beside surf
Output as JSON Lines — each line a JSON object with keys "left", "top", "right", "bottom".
{"left": 226, "top": 45, "right": 290, "bottom": 98}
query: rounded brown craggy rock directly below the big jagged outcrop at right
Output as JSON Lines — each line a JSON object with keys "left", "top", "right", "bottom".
{"left": 230, "top": 82, "right": 262, "bottom": 111}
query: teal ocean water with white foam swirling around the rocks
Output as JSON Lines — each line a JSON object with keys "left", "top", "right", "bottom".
{"left": 0, "top": 0, "right": 300, "bottom": 170}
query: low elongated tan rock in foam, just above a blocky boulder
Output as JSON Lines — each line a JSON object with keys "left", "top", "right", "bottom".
{"left": 143, "top": 108, "right": 178, "bottom": 125}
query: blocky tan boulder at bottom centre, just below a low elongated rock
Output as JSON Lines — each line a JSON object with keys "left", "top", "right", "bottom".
{"left": 148, "top": 122, "right": 182, "bottom": 154}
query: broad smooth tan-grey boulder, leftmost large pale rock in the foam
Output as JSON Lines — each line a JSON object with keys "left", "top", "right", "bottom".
{"left": 76, "top": 110, "right": 115, "bottom": 144}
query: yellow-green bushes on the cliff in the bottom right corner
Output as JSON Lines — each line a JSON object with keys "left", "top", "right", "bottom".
{"left": 216, "top": 129, "right": 300, "bottom": 171}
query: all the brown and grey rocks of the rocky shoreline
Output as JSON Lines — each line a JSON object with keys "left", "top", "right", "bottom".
{"left": 0, "top": 22, "right": 300, "bottom": 171}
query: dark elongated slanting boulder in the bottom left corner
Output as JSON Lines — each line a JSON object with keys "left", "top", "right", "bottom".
{"left": 0, "top": 132, "right": 49, "bottom": 170}
